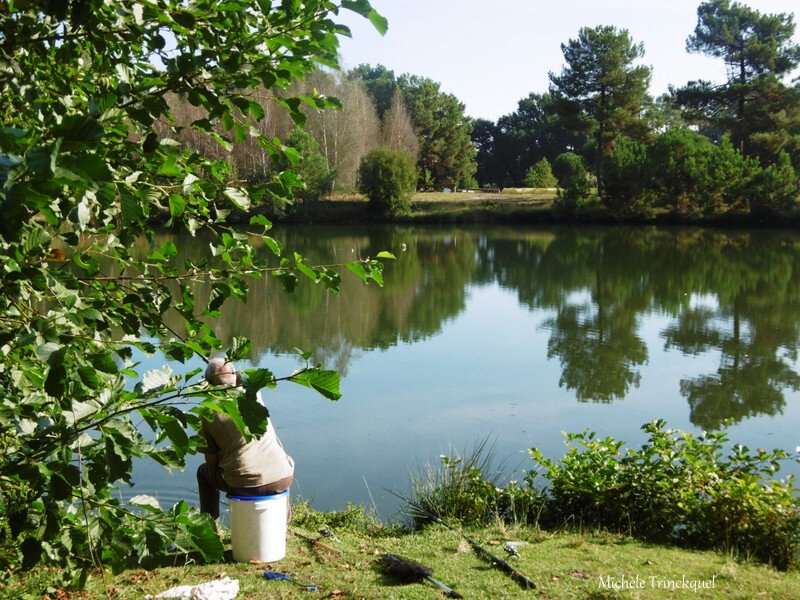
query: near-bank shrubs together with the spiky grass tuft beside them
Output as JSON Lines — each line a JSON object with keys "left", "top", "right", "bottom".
{"left": 406, "top": 420, "right": 800, "bottom": 569}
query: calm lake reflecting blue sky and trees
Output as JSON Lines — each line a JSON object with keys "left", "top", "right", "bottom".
{"left": 126, "top": 226, "right": 800, "bottom": 519}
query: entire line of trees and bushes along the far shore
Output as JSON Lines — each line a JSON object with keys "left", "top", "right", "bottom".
{"left": 159, "top": 0, "right": 800, "bottom": 216}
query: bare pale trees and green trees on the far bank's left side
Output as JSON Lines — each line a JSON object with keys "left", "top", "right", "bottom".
{"left": 162, "top": 65, "right": 476, "bottom": 206}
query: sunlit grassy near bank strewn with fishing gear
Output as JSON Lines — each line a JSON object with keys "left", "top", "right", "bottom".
{"left": 6, "top": 506, "right": 800, "bottom": 600}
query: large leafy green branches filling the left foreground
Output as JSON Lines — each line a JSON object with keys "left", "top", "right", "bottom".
{"left": 0, "top": 0, "right": 386, "bottom": 586}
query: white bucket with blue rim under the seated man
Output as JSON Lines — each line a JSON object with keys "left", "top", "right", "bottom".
{"left": 228, "top": 490, "right": 289, "bottom": 562}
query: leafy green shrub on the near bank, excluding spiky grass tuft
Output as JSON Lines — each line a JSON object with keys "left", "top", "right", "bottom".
{"left": 528, "top": 420, "right": 800, "bottom": 569}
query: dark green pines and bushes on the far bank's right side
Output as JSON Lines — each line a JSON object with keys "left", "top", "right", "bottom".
{"left": 472, "top": 0, "right": 800, "bottom": 215}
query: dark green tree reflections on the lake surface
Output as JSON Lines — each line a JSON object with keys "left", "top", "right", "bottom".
{"left": 159, "top": 226, "right": 800, "bottom": 428}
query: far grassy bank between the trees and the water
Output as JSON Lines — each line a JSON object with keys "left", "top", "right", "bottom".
{"left": 268, "top": 188, "right": 800, "bottom": 226}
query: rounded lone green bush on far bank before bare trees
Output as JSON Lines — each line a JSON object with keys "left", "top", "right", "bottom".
{"left": 358, "top": 148, "right": 417, "bottom": 216}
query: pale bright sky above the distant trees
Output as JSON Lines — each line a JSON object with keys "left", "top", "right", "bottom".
{"left": 340, "top": 0, "right": 800, "bottom": 121}
